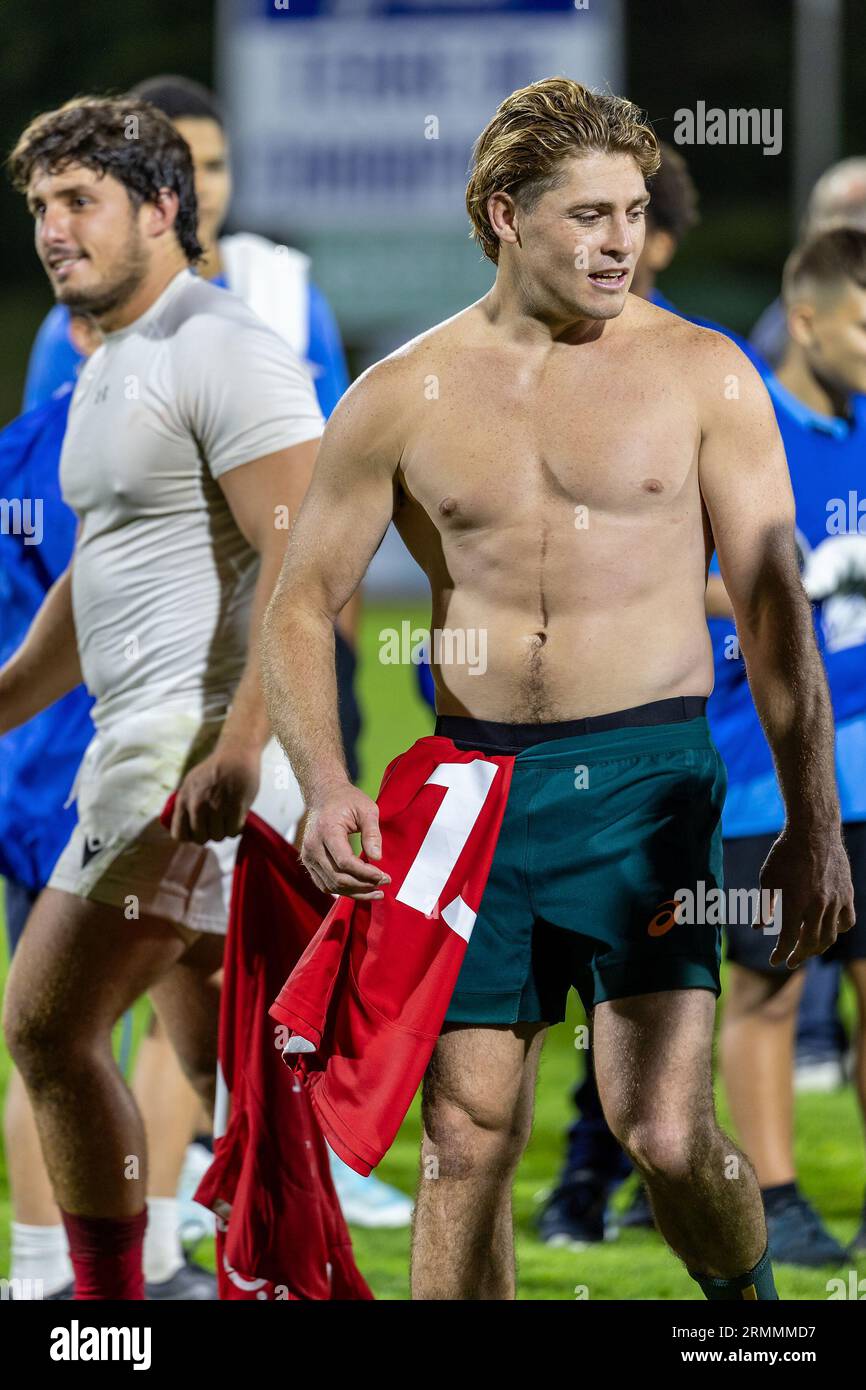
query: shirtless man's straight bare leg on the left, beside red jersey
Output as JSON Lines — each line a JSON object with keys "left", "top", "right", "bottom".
{"left": 411, "top": 1023, "right": 546, "bottom": 1300}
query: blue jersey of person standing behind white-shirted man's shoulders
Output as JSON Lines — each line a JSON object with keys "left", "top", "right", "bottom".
{"left": 24, "top": 275, "right": 349, "bottom": 420}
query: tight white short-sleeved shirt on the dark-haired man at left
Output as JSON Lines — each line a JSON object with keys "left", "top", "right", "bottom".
{"left": 60, "top": 271, "right": 324, "bottom": 730}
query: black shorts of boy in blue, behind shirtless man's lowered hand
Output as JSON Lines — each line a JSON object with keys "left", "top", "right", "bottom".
{"left": 724, "top": 820, "right": 866, "bottom": 974}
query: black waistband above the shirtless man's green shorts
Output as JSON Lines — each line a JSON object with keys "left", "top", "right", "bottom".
{"left": 434, "top": 695, "right": 706, "bottom": 753}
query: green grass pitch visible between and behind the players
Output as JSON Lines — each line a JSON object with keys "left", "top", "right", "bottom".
{"left": 0, "top": 606, "right": 866, "bottom": 1300}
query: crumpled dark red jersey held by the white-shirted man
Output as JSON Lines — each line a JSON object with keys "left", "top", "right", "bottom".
{"left": 163, "top": 798, "right": 373, "bottom": 1301}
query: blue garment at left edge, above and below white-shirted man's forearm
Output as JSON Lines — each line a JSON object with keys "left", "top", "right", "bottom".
{"left": 0, "top": 388, "right": 93, "bottom": 891}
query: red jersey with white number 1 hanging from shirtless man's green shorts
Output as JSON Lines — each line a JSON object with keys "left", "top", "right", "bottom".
{"left": 270, "top": 735, "right": 514, "bottom": 1176}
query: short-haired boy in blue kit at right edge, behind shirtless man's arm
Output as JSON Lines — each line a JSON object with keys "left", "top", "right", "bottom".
{"left": 708, "top": 228, "right": 866, "bottom": 1265}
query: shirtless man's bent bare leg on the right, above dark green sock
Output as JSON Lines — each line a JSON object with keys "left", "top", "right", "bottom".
{"left": 594, "top": 990, "right": 767, "bottom": 1279}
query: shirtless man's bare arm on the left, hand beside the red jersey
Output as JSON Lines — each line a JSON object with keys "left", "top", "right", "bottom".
{"left": 261, "top": 361, "right": 402, "bottom": 898}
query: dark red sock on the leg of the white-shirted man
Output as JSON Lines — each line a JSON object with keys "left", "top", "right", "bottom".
{"left": 60, "top": 1208, "right": 147, "bottom": 1300}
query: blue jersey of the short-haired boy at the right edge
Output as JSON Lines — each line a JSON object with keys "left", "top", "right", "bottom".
{"left": 708, "top": 375, "right": 866, "bottom": 838}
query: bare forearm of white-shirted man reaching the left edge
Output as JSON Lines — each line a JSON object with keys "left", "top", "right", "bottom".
{"left": 0, "top": 570, "right": 82, "bottom": 734}
